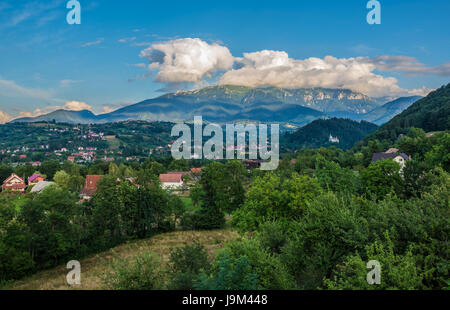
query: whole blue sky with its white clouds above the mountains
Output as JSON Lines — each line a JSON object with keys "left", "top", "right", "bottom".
{"left": 0, "top": 0, "right": 450, "bottom": 122}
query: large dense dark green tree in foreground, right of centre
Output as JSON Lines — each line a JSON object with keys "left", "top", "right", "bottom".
{"left": 281, "top": 193, "right": 368, "bottom": 289}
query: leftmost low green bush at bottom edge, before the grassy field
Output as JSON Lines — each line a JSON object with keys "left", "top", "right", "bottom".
{"left": 102, "top": 253, "right": 164, "bottom": 290}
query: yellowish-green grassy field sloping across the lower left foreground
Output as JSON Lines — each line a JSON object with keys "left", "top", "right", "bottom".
{"left": 6, "top": 229, "right": 239, "bottom": 290}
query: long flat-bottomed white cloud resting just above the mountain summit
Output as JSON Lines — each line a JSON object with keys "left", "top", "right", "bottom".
{"left": 219, "top": 50, "right": 432, "bottom": 97}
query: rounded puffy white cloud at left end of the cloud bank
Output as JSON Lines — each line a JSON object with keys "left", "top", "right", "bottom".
{"left": 140, "top": 38, "right": 234, "bottom": 83}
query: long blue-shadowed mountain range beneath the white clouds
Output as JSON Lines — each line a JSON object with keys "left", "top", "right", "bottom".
{"left": 13, "top": 85, "right": 420, "bottom": 126}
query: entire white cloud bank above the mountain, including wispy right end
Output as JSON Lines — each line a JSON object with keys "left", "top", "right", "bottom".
{"left": 137, "top": 38, "right": 450, "bottom": 97}
